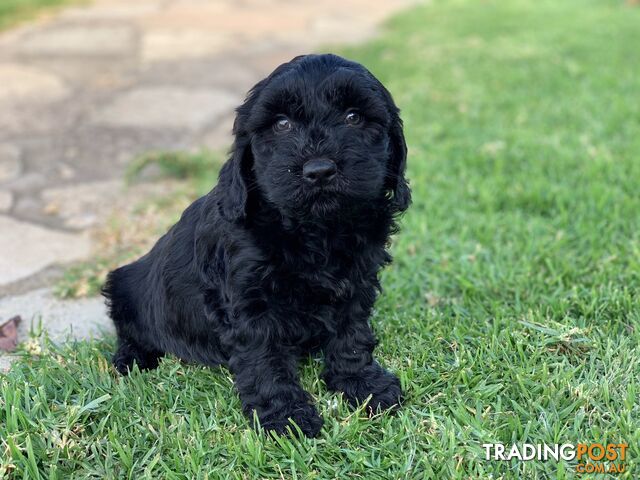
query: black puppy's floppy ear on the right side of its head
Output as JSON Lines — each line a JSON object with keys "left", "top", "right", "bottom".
{"left": 387, "top": 109, "right": 411, "bottom": 212}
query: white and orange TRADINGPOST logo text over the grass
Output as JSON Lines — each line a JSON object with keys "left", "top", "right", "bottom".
{"left": 482, "top": 443, "right": 629, "bottom": 473}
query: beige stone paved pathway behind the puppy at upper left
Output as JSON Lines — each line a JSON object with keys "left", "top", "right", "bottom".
{"left": 0, "top": 0, "right": 415, "bottom": 370}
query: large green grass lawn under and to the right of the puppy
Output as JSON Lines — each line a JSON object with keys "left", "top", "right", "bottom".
{"left": 0, "top": 0, "right": 640, "bottom": 479}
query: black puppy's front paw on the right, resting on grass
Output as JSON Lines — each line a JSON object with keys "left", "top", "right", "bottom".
{"left": 325, "top": 363, "right": 402, "bottom": 413}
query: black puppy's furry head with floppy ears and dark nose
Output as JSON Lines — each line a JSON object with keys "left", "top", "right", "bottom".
{"left": 220, "top": 55, "right": 411, "bottom": 221}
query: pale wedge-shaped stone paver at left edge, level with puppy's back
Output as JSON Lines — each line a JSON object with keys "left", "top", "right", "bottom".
{"left": 0, "top": 215, "right": 91, "bottom": 285}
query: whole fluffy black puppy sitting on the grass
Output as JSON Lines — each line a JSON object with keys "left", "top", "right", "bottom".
{"left": 103, "top": 55, "right": 410, "bottom": 436}
